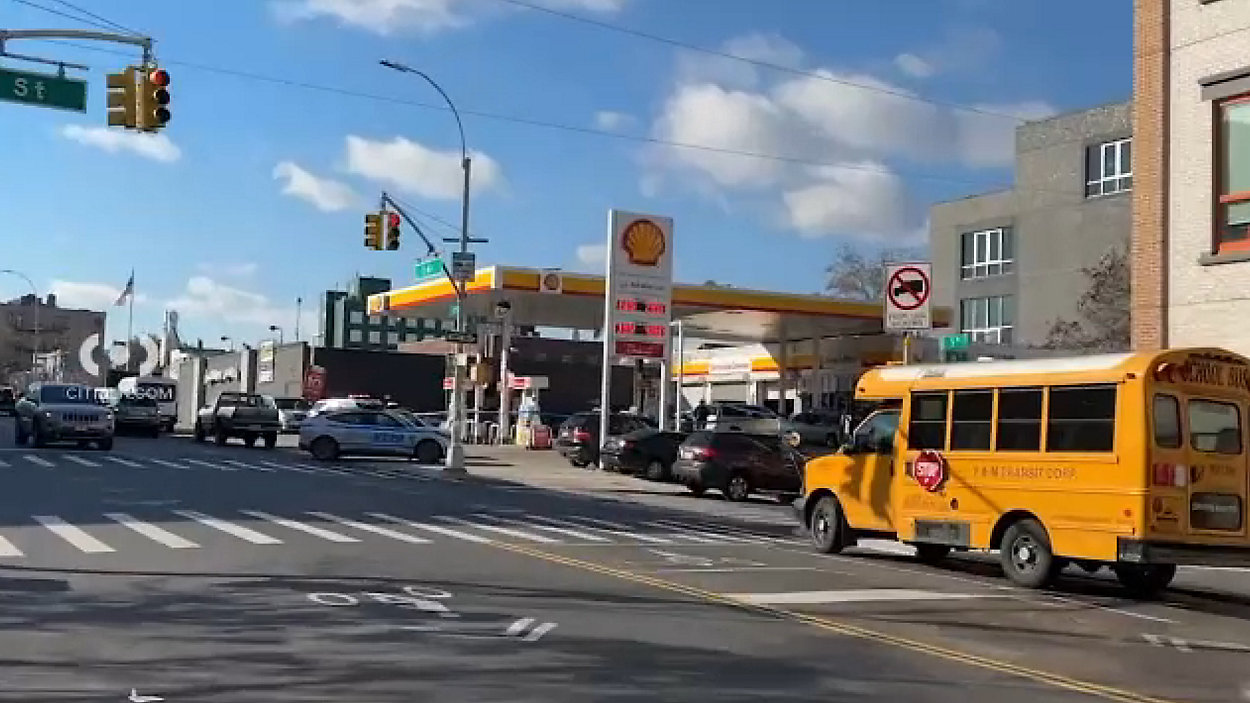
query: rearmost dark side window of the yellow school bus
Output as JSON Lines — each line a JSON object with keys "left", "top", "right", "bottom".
{"left": 1046, "top": 384, "right": 1115, "bottom": 452}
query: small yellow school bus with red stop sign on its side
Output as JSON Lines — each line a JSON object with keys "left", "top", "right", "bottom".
{"left": 795, "top": 349, "right": 1250, "bottom": 595}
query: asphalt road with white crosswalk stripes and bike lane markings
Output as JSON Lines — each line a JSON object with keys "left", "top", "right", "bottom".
{"left": 0, "top": 419, "right": 1250, "bottom": 703}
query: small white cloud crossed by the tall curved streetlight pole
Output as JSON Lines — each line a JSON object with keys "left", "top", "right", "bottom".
{"left": 346, "top": 135, "right": 503, "bottom": 200}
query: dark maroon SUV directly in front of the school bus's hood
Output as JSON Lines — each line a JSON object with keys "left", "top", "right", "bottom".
{"left": 673, "top": 430, "right": 803, "bottom": 503}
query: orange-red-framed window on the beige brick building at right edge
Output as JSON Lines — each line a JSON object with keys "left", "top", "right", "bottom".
{"left": 1215, "top": 95, "right": 1250, "bottom": 250}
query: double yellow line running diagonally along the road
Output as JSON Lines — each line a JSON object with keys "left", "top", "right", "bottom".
{"left": 493, "top": 542, "right": 1171, "bottom": 703}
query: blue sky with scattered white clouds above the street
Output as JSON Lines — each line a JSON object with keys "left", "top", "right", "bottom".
{"left": 0, "top": 0, "right": 1131, "bottom": 341}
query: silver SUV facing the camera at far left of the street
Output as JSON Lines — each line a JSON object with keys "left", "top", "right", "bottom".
{"left": 14, "top": 383, "right": 114, "bottom": 449}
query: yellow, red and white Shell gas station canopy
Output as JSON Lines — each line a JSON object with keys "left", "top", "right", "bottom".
{"left": 368, "top": 266, "right": 950, "bottom": 343}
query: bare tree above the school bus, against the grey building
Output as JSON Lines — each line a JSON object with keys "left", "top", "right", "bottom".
{"left": 1044, "top": 248, "right": 1131, "bottom": 352}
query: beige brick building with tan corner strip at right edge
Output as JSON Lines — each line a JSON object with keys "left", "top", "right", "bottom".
{"left": 1131, "top": 0, "right": 1250, "bottom": 355}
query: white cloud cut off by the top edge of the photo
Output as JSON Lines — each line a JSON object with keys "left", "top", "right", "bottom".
{"left": 270, "top": 0, "right": 626, "bottom": 35}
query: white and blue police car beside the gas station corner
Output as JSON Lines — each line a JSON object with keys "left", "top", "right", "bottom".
{"left": 300, "top": 408, "right": 450, "bottom": 464}
